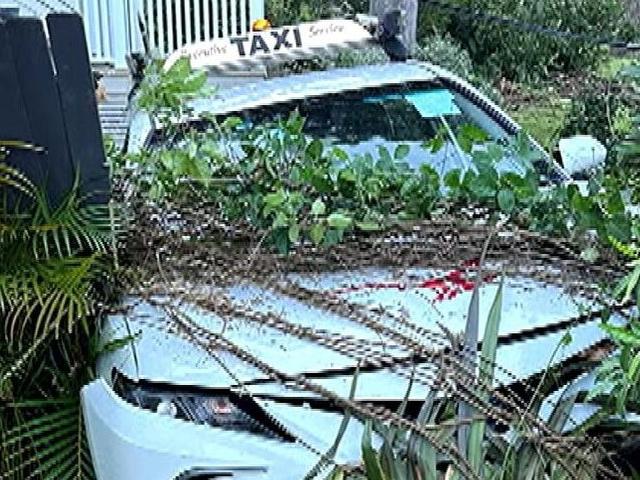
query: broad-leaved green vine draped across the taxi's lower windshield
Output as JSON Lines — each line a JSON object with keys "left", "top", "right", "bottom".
{"left": 127, "top": 87, "right": 631, "bottom": 252}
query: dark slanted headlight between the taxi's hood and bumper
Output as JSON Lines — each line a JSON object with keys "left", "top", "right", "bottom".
{"left": 113, "top": 371, "right": 295, "bottom": 442}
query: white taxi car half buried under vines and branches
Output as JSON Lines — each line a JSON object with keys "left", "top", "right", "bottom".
{"left": 82, "top": 17, "right": 605, "bottom": 480}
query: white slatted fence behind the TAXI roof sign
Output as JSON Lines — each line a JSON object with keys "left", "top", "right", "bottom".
{"left": 10, "top": 0, "right": 265, "bottom": 67}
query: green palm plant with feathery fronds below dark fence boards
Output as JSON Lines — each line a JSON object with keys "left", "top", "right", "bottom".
{"left": 0, "top": 142, "right": 114, "bottom": 480}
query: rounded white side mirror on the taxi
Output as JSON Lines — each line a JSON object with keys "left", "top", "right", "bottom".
{"left": 558, "top": 135, "right": 607, "bottom": 180}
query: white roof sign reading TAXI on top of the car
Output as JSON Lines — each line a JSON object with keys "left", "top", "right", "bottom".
{"left": 165, "top": 19, "right": 373, "bottom": 68}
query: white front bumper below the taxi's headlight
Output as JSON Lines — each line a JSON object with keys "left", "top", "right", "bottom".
{"left": 82, "top": 379, "right": 317, "bottom": 480}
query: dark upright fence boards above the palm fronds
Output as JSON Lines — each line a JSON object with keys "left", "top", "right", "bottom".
{"left": 0, "top": 14, "right": 110, "bottom": 204}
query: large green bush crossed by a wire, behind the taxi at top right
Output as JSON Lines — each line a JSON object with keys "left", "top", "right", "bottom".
{"left": 421, "top": 0, "right": 624, "bottom": 81}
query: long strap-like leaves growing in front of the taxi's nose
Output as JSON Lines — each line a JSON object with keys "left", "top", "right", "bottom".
{"left": 328, "top": 285, "right": 584, "bottom": 480}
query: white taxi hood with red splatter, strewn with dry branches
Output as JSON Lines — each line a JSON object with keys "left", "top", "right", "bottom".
{"left": 98, "top": 268, "right": 604, "bottom": 399}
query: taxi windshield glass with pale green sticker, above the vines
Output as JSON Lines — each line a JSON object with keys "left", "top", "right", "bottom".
{"left": 232, "top": 85, "right": 528, "bottom": 178}
